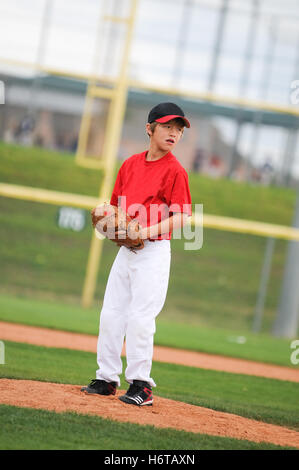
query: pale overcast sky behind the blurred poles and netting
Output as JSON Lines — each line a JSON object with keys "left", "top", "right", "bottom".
{"left": 0, "top": 0, "right": 299, "bottom": 173}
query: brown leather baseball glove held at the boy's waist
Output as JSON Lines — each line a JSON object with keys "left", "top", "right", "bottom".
{"left": 91, "top": 202, "right": 144, "bottom": 252}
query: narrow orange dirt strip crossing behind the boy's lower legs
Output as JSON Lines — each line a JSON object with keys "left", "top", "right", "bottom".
{"left": 0, "top": 322, "right": 299, "bottom": 382}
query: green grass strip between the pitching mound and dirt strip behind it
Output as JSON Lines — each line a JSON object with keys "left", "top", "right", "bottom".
{"left": 0, "top": 341, "right": 299, "bottom": 429}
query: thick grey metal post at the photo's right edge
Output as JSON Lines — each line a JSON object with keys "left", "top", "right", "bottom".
{"left": 273, "top": 189, "right": 299, "bottom": 338}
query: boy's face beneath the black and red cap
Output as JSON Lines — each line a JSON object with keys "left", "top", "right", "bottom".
{"left": 146, "top": 119, "right": 184, "bottom": 152}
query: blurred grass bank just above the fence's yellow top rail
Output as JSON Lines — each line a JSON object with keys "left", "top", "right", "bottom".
{"left": 0, "top": 141, "right": 296, "bottom": 225}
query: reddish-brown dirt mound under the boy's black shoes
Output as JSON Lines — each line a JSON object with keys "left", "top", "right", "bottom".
{"left": 0, "top": 379, "right": 299, "bottom": 448}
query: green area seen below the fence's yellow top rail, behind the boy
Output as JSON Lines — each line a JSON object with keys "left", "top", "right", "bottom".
{"left": 0, "top": 198, "right": 286, "bottom": 331}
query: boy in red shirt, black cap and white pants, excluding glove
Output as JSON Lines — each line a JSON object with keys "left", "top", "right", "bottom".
{"left": 82, "top": 103, "right": 192, "bottom": 406}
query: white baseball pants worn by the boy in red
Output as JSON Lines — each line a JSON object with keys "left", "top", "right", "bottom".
{"left": 96, "top": 240, "right": 171, "bottom": 387}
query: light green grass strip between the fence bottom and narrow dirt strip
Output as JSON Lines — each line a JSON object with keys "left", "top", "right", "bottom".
{"left": 0, "top": 295, "right": 298, "bottom": 368}
